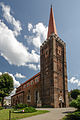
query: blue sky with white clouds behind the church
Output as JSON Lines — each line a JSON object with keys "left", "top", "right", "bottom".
{"left": 0, "top": 0, "right": 80, "bottom": 90}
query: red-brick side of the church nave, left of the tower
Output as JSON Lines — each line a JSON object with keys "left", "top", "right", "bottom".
{"left": 12, "top": 73, "right": 40, "bottom": 106}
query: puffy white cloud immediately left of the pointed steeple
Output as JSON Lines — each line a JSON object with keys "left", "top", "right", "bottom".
{"left": 24, "top": 23, "right": 48, "bottom": 49}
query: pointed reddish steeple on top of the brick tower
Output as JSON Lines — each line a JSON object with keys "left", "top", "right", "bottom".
{"left": 47, "top": 5, "right": 57, "bottom": 39}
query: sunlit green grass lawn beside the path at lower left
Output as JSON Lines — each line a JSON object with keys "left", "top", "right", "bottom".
{"left": 0, "top": 109, "right": 49, "bottom": 120}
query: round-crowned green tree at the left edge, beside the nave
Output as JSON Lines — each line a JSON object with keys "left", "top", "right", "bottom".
{"left": 0, "top": 73, "right": 14, "bottom": 107}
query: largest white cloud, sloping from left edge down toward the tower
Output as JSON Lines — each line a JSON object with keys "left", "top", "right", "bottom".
{"left": 0, "top": 21, "right": 39, "bottom": 66}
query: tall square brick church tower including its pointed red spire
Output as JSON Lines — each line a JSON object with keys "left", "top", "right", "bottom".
{"left": 40, "top": 6, "right": 68, "bottom": 108}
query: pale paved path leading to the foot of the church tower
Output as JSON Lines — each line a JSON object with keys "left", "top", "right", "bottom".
{"left": 20, "top": 108, "right": 75, "bottom": 120}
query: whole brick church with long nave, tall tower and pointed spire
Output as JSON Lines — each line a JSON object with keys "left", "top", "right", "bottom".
{"left": 11, "top": 6, "right": 68, "bottom": 108}
